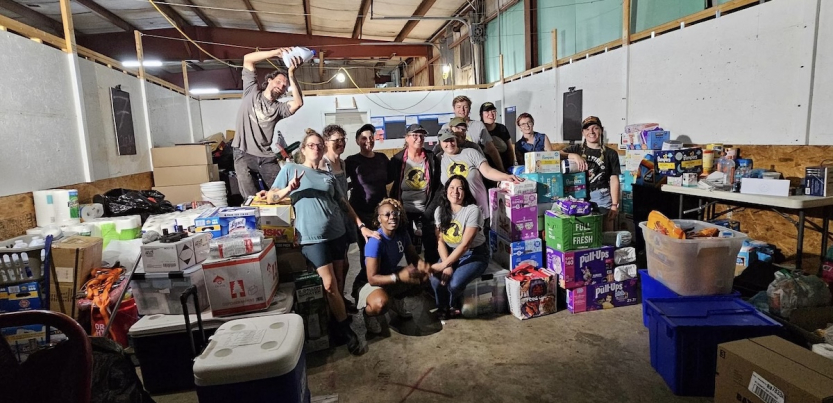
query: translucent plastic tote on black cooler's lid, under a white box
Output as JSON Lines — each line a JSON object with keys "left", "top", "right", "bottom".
{"left": 130, "top": 265, "right": 209, "bottom": 315}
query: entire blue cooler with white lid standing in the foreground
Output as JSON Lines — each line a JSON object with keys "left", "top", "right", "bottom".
{"left": 194, "top": 314, "right": 310, "bottom": 403}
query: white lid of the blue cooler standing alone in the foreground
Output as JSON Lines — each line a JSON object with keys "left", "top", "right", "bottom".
{"left": 194, "top": 313, "right": 304, "bottom": 386}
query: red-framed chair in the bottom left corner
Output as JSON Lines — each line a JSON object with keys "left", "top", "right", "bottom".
{"left": 0, "top": 311, "right": 93, "bottom": 403}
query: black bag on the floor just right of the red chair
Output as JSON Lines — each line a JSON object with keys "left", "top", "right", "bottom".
{"left": 90, "top": 337, "right": 154, "bottom": 403}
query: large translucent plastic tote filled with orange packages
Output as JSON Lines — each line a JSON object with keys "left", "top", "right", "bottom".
{"left": 639, "top": 220, "right": 746, "bottom": 296}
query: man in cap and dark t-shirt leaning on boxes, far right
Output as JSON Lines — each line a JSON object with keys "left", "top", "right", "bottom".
{"left": 561, "top": 116, "right": 622, "bottom": 231}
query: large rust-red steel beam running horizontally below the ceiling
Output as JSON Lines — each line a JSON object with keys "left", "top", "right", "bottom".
{"left": 78, "top": 27, "right": 430, "bottom": 61}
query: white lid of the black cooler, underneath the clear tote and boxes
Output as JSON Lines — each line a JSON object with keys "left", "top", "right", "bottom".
{"left": 128, "top": 282, "right": 295, "bottom": 337}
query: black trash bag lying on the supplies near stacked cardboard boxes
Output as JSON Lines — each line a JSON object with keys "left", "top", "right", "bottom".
{"left": 93, "top": 189, "right": 175, "bottom": 223}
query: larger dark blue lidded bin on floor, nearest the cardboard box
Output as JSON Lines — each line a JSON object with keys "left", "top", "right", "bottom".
{"left": 646, "top": 296, "right": 781, "bottom": 396}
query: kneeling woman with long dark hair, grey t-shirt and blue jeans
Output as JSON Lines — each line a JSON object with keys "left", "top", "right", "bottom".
{"left": 431, "top": 175, "right": 491, "bottom": 319}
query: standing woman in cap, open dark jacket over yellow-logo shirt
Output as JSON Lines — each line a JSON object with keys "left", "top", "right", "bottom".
{"left": 388, "top": 124, "right": 440, "bottom": 262}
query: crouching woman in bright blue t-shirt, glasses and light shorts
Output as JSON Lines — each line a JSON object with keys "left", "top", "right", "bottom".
{"left": 353, "top": 198, "right": 430, "bottom": 334}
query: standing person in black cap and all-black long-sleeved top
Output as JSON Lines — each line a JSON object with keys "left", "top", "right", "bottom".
{"left": 344, "top": 124, "right": 390, "bottom": 272}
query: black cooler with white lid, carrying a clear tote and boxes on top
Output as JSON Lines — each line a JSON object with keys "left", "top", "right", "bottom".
{"left": 128, "top": 283, "right": 295, "bottom": 394}
